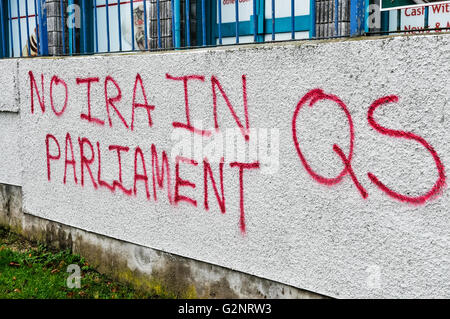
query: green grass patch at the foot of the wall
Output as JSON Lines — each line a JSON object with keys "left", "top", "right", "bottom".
{"left": 0, "top": 228, "right": 158, "bottom": 299}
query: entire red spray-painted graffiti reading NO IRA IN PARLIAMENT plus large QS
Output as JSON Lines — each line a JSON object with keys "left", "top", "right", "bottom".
{"left": 29, "top": 71, "right": 446, "bottom": 238}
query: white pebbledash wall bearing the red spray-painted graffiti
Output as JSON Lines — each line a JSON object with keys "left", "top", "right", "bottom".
{"left": 0, "top": 35, "right": 450, "bottom": 297}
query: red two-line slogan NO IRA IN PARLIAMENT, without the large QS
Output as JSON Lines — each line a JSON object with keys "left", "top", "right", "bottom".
{"left": 29, "top": 71, "right": 259, "bottom": 234}
